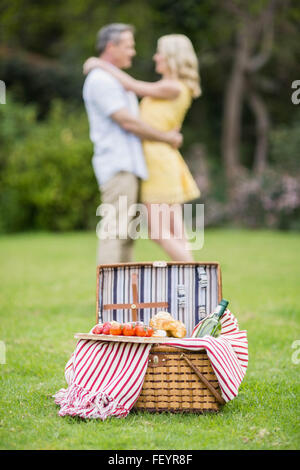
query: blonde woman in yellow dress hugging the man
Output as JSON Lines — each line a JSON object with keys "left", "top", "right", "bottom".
{"left": 84, "top": 34, "right": 201, "bottom": 261}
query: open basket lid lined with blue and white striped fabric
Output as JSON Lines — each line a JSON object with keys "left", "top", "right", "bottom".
{"left": 96, "top": 261, "right": 222, "bottom": 336}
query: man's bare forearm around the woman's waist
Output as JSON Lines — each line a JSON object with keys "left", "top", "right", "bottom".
{"left": 111, "top": 108, "right": 183, "bottom": 148}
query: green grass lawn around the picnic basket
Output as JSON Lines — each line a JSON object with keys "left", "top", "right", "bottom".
{"left": 0, "top": 230, "right": 300, "bottom": 450}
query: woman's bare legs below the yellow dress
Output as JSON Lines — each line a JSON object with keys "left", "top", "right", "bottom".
{"left": 146, "top": 203, "right": 193, "bottom": 261}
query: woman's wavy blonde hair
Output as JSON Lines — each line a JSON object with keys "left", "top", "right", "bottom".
{"left": 157, "top": 34, "right": 201, "bottom": 98}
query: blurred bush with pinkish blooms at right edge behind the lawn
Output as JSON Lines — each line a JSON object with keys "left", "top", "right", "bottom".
{"left": 200, "top": 114, "right": 300, "bottom": 230}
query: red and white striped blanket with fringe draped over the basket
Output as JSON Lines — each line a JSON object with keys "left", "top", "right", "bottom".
{"left": 54, "top": 309, "right": 248, "bottom": 420}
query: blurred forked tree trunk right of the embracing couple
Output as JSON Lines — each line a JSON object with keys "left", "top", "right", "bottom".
{"left": 222, "top": 0, "right": 280, "bottom": 199}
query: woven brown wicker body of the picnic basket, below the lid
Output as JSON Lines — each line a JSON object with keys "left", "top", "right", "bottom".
{"left": 134, "top": 346, "right": 224, "bottom": 413}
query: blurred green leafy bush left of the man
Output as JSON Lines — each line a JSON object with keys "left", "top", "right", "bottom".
{"left": 0, "top": 98, "right": 100, "bottom": 232}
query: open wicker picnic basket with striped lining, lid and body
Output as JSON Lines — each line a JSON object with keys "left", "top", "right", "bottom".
{"left": 96, "top": 261, "right": 224, "bottom": 413}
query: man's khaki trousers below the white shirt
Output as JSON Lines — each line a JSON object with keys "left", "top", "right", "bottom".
{"left": 97, "top": 171, "right": 139, "bottom": 264}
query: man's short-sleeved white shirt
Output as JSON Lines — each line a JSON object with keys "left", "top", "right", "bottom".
{"left": 83, "top": 68, "right": 148, "bottom": 186}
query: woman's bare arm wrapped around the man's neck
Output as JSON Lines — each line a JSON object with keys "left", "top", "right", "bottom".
{"left": 83, "top": 57, "right": 180, "bottom": 99}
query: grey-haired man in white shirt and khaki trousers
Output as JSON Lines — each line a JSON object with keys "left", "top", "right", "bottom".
{"left": 83, "top": 23, "right": 182, "bottom": 264}
